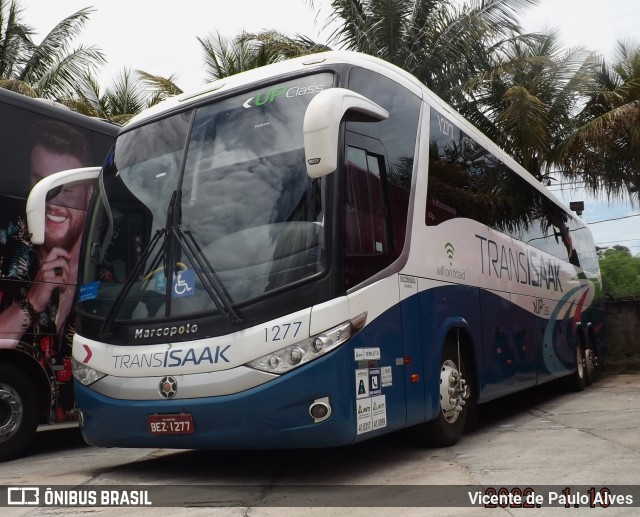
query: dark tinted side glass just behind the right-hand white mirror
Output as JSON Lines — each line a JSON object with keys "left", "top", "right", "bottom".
{"left": 343, "top": 69, "right": 421, "bottom": 287}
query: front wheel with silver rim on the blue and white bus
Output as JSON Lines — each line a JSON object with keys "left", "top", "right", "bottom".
{"left": 421, "top": 342, "right": 472, "bottom": 447}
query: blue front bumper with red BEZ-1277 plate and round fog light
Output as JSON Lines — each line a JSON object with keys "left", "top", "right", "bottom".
{"left": 75, "top": 351, "right": 356, "bottom": 449}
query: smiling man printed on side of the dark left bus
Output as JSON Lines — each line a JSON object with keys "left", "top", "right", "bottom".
{"left": 0, "top": 120, "right": 91, "bottom": 420}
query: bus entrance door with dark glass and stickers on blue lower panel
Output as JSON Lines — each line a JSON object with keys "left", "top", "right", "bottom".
{"left": 342, "top": 131, "right": 412, "bottom": 434}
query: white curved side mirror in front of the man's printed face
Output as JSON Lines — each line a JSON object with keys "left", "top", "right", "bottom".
{"left": 27, "top": 167, "right": 100, "bottom": 244}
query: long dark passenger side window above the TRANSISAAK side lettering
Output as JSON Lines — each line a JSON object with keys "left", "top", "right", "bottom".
{"left": 425, "top": 106, "right": 589, "bottom": 266}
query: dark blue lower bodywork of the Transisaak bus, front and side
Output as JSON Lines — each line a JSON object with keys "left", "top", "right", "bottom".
{"left": 76, "top": 285, "right": 604, "bottom": 449}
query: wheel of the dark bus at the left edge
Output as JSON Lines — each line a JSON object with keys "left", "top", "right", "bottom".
{"left": 0, "top": 364, "right": 38, "bottom": 461}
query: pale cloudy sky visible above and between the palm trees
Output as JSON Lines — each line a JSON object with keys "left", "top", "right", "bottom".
{"left": 20, "top": 0, "right": 640, "bottom": 254}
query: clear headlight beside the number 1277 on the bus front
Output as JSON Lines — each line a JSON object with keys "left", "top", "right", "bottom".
{"left": 247, "top": 321, "right": 353, "bottom": 374}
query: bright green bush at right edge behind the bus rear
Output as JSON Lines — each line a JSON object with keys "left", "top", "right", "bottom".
{"left": 600, "top": 246, "right": 640, "bottom": 300}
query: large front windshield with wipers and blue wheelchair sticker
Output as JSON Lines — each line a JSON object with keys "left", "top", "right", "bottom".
{"left": 79, "top": 73, "right": 332, "bottom": 319}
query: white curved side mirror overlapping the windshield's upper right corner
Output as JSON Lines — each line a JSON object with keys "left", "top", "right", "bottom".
{"left": 303, "top": 88, "right": 389, "bottom": 178}
